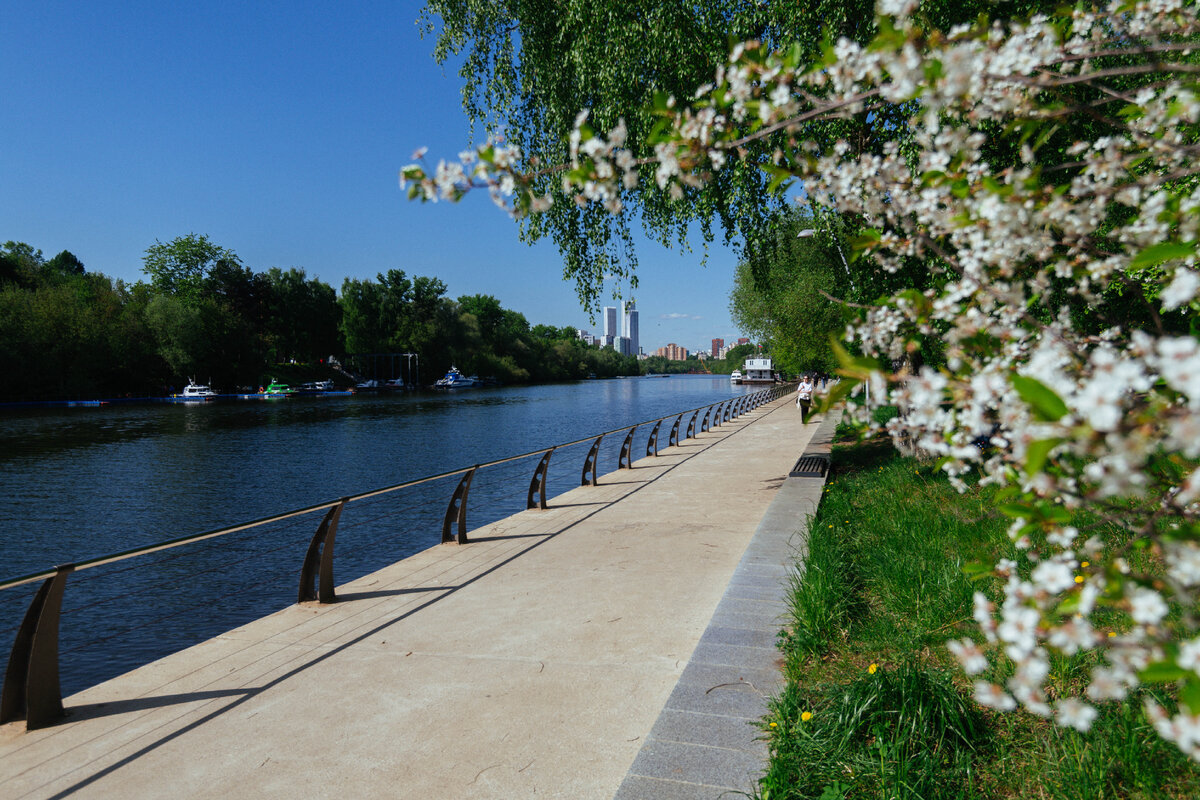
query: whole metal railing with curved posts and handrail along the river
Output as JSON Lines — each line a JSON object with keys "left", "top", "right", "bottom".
{"left": 0, "top": 384, "right": 792, "bottom": 730}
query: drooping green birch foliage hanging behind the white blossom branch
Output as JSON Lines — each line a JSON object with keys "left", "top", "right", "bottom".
{"left": 421, "top": 0, "right": 1058, "bottom": 307}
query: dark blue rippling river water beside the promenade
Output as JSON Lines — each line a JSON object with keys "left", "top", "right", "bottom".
{"left": 0, "top": 375, "right": 754, "bottom": 694}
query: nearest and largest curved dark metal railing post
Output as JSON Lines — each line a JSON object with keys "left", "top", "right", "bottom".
{"left": 0, "top": 564, "right": 74, "bottom": 730}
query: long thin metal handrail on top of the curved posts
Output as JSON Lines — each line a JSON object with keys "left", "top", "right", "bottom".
{"left": 0, "top": 381, "right": 787, "bottom": 591}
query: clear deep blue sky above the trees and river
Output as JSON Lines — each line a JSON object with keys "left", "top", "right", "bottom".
{"left": 0, "top": 0, "right": 738, "bottom": 351}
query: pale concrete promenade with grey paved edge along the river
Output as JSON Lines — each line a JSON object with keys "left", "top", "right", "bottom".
{"left": 0, "top": 397, "right": 829, "bottom": 800}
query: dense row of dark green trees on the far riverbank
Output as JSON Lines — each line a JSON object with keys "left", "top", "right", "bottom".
{"left": 0, "top": 236, "right": 637, "bottom": 401}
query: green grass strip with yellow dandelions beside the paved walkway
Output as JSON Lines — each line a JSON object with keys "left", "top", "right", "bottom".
{"left": 758, "top": 441, "right": 1200, "bottom": 800}
